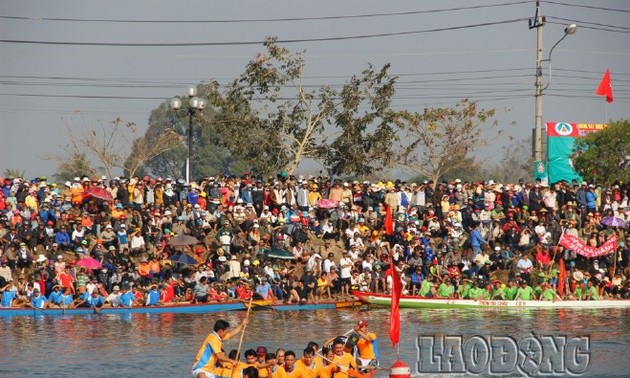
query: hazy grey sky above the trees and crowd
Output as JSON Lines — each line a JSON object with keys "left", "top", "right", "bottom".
{"left": 0, "top": 0, "right": 630, "bottom": 177}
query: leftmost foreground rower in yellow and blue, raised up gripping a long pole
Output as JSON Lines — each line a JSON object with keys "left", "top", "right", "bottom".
{"left": 192, "top": 318, "right": 247, "bottom": 378}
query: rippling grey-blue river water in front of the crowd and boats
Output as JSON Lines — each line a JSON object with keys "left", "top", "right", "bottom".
{"left": 0, "top": 309, "right": 630, "bottom": 377}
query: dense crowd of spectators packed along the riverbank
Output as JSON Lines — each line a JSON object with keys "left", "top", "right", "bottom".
{"left": 0, "top": 174, "right": 630, "bottom": 307}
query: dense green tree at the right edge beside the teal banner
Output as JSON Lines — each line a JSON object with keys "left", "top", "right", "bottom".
{"left": 571, "top": 120, "right": 630, "bottom": 184}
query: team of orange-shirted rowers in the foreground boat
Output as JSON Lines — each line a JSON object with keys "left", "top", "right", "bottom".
{"left": 192, "top": 318, "right": 378, "bottom": 378}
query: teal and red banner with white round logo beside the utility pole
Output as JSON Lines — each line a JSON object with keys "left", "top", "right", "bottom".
{"left": 547, "top": 122, "right": 606, "bottom": 183}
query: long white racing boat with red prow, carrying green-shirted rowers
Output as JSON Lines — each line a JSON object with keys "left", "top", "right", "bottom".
{"left": 353, "top": 291, "right": 630, "bottom": 309}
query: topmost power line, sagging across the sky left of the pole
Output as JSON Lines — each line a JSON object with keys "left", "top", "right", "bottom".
{"left": 0, "top": 1, "right": 529, "bottom": 24}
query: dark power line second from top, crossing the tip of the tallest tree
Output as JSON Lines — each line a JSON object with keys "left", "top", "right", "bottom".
{"left": 0, "top": 18, "right": 527, "bottom": 47}
